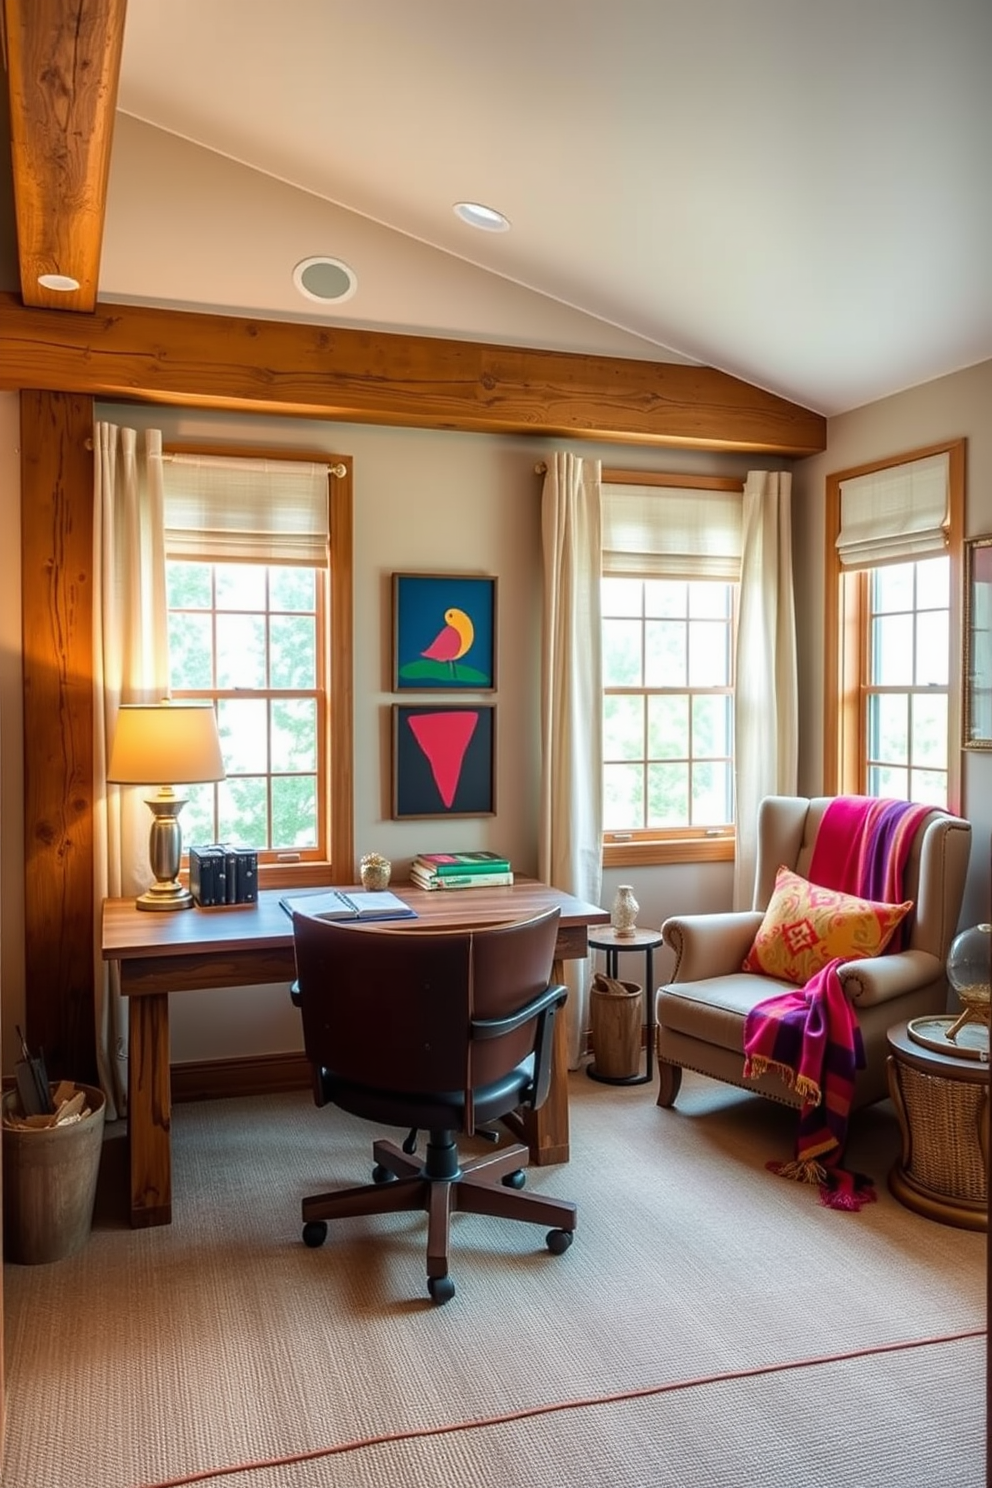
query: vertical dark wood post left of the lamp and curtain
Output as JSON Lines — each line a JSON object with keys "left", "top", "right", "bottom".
{"left": 21, "top": 386, "right": 97, "bottom": 1080}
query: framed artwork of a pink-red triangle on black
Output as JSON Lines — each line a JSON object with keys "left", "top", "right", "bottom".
{"left": 393, "top": 702, "right": 497, "bottom": 821}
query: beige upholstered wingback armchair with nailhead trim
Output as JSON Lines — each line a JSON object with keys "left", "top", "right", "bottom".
{"left": 656, "top": 796, "right": 971, "bottom": 1109}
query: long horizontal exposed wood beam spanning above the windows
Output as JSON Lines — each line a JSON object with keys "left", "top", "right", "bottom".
{"left": 0, "top": 291, "right": 827, "bottom": 457}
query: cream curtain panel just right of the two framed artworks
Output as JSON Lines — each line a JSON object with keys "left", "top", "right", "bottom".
{"left": 538, "top": 454, "right": 602, "bottom": 1070}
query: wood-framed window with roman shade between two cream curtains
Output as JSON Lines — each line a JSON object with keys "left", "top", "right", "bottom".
{"left": 601, "top": 470, "right": 742, "bottom": 866}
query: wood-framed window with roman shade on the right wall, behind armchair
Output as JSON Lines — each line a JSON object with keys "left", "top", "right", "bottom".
{"left": 824, "top": 442, "right": 964, "bottom": 809}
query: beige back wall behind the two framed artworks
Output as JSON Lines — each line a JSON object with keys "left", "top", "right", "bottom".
{"left": 77, "top": 406, "right": 754, "bottom": 1062}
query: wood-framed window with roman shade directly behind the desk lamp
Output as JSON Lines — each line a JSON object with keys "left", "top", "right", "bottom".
{"left": 164, "top": 451, "right": 351, "bottom": 881}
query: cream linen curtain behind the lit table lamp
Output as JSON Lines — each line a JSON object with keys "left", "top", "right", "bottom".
{"left": 94, "top": 423, "right": 170, "bottom": 1117}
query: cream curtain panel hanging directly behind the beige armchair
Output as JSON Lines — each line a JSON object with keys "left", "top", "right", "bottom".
{"left": 733, "top": 470, "right": 799, "bottom": 909}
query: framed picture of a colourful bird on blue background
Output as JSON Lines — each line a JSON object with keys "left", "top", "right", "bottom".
{"left": 393, "top": 573, "right": 497, "bottom": 692}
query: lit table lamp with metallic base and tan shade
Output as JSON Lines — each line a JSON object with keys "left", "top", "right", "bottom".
{"left": 107, "top": 701, "right": 225, "bottom": 909}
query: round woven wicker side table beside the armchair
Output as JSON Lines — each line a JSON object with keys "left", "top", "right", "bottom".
{"left": 886, "top": 1022, "right": 989, "bottom": 1231}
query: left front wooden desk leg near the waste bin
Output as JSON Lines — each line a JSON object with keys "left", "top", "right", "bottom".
{"left": 128, "top": 992, "right": 173, "bottom": 1229}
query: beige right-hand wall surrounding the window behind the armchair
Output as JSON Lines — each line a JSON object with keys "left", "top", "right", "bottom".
{"left": 793, "top": 362, "right": 992, "bottom": 926}
